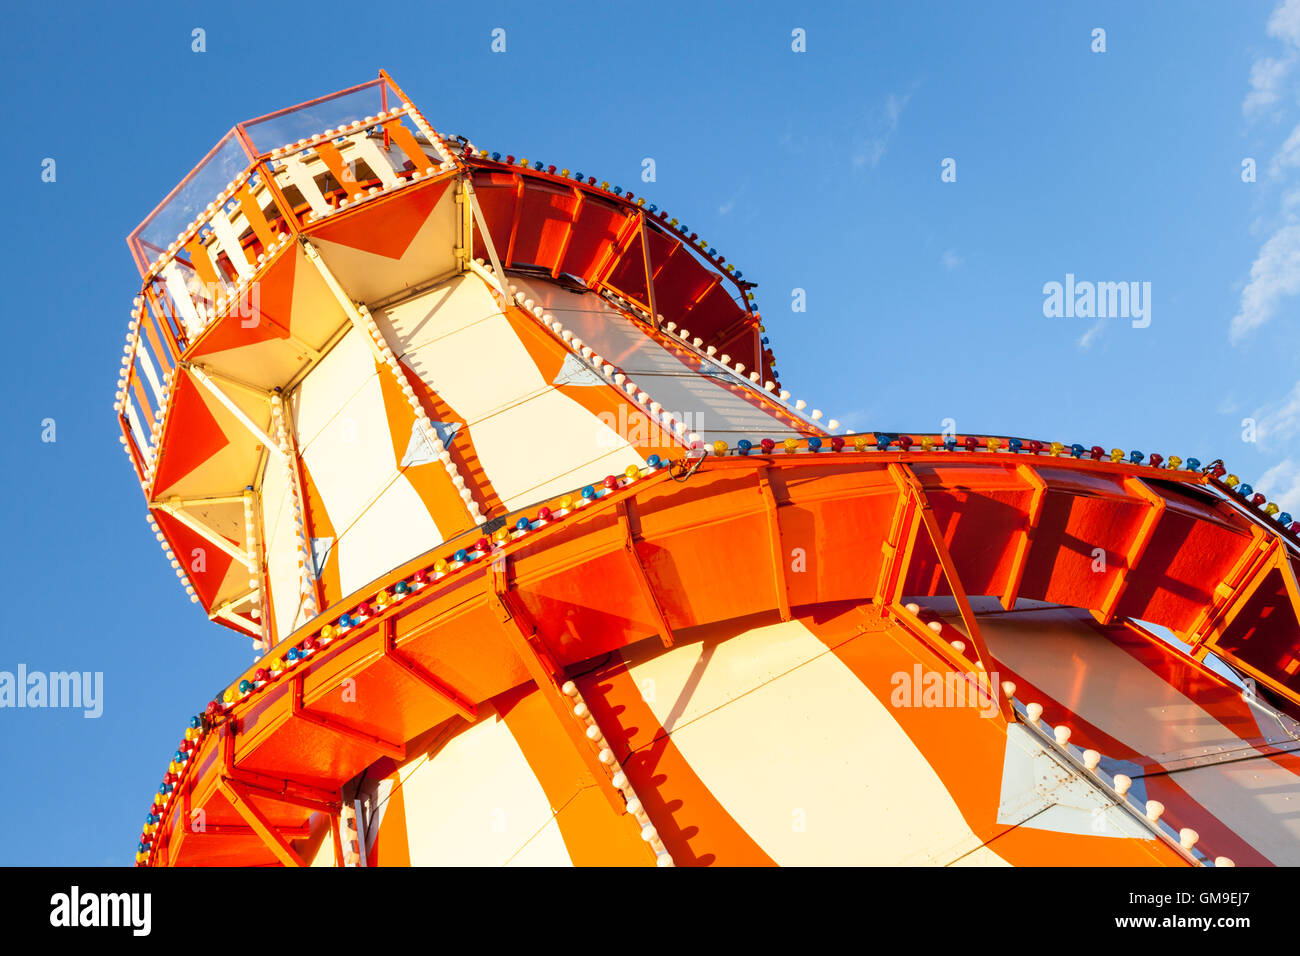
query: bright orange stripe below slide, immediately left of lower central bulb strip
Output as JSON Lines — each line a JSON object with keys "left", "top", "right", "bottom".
{"left": 493, "top": 683, "right": 644, "bottom": 866}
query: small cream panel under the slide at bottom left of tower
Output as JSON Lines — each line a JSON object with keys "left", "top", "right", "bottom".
{"left": 402, "top": 708, "right": 571, "bottom": 866}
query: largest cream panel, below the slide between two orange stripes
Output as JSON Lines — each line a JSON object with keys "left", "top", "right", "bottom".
{"left": 632, "top": 622, "right": 980, "bottom": 866}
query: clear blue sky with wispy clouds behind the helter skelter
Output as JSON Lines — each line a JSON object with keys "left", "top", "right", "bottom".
{"left": 0, "top": 0, "right": 1300, "bottom": 865}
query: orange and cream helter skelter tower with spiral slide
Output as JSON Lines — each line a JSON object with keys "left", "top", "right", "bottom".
{"left": 116, "top": 73, "right": 1300, "bottom": 866}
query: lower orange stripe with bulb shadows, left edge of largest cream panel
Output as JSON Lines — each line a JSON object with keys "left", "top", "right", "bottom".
{"left": 577, "top": 663, "right": 774, "bottom": 866}
